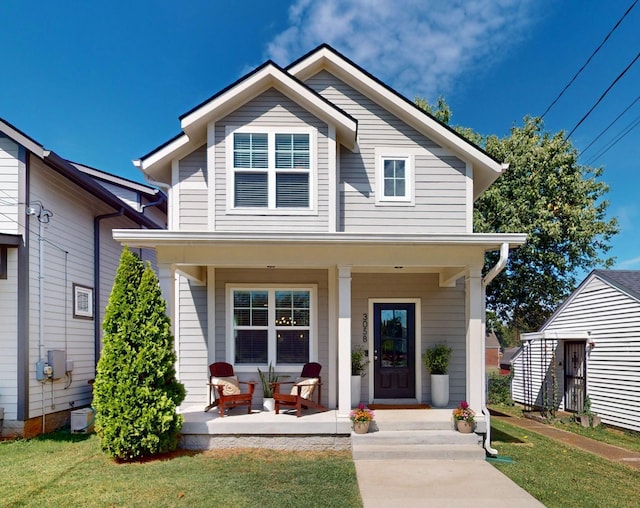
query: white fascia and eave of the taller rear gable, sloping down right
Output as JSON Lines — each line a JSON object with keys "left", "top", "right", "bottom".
{"left": 288, "top": 48, "right": 508, "bottom": 199}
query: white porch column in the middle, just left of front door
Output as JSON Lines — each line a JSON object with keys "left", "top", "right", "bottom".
{"left": 338, "top": 266, "right": 351, "bottom": 417}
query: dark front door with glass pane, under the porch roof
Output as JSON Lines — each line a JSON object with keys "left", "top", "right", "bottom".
{"left": 373, "top": 303, "right": 416, "bottom": 399}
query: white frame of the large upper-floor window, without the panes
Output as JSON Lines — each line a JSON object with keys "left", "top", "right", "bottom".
{"left": 225, "top": 124, "right": 318, "bottom": 215}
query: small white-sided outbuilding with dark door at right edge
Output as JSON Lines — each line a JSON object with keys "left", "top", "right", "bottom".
{"left": 512, "top": 270, "right": 640, "bottom": 431}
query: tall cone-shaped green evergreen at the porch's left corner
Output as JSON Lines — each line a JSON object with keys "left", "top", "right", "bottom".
{"left": 93, "top": 248, "right": 185, "bottom": 460}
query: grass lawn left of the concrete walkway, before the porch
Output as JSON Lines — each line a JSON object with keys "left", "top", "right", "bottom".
{"left": 0, "top": 431, "right": 362, "bottom": 507}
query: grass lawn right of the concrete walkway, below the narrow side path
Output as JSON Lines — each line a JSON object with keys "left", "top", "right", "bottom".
{"left": 491, "top": 420, "right": 640, "bottom": 508}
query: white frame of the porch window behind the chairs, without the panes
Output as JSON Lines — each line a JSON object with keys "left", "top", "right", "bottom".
{"left": 225, "top": 284, "right": 318, "bottom": 373}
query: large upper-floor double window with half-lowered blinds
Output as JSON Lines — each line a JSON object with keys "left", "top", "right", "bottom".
{"left": 227, "top": 127, "right": 313, "bottom": 211}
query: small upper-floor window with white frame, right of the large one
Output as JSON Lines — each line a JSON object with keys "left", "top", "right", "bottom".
{"left": 376, "top": 149, "right": 414, "bottom": 206}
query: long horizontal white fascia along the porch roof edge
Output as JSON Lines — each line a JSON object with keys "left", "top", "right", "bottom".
{"left": 113, "top": 229, "right": 527, "bottom": 251}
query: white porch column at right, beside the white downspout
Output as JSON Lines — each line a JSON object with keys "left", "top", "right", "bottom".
{"left": 465, "top": 266, "right": 485, "bottom": 413}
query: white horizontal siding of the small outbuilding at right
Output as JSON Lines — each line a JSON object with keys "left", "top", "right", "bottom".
{"left": 514, "top": 277, "right": 640, "bottom": 431}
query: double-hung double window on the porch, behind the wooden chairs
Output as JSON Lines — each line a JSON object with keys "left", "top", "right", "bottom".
{"left": 227, "top": 287, "right": 315, "bottom": 367}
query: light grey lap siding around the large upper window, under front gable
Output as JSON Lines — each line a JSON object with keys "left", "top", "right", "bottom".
{"left": 215, "top": 89, "right": 329, "bottom": 232}
